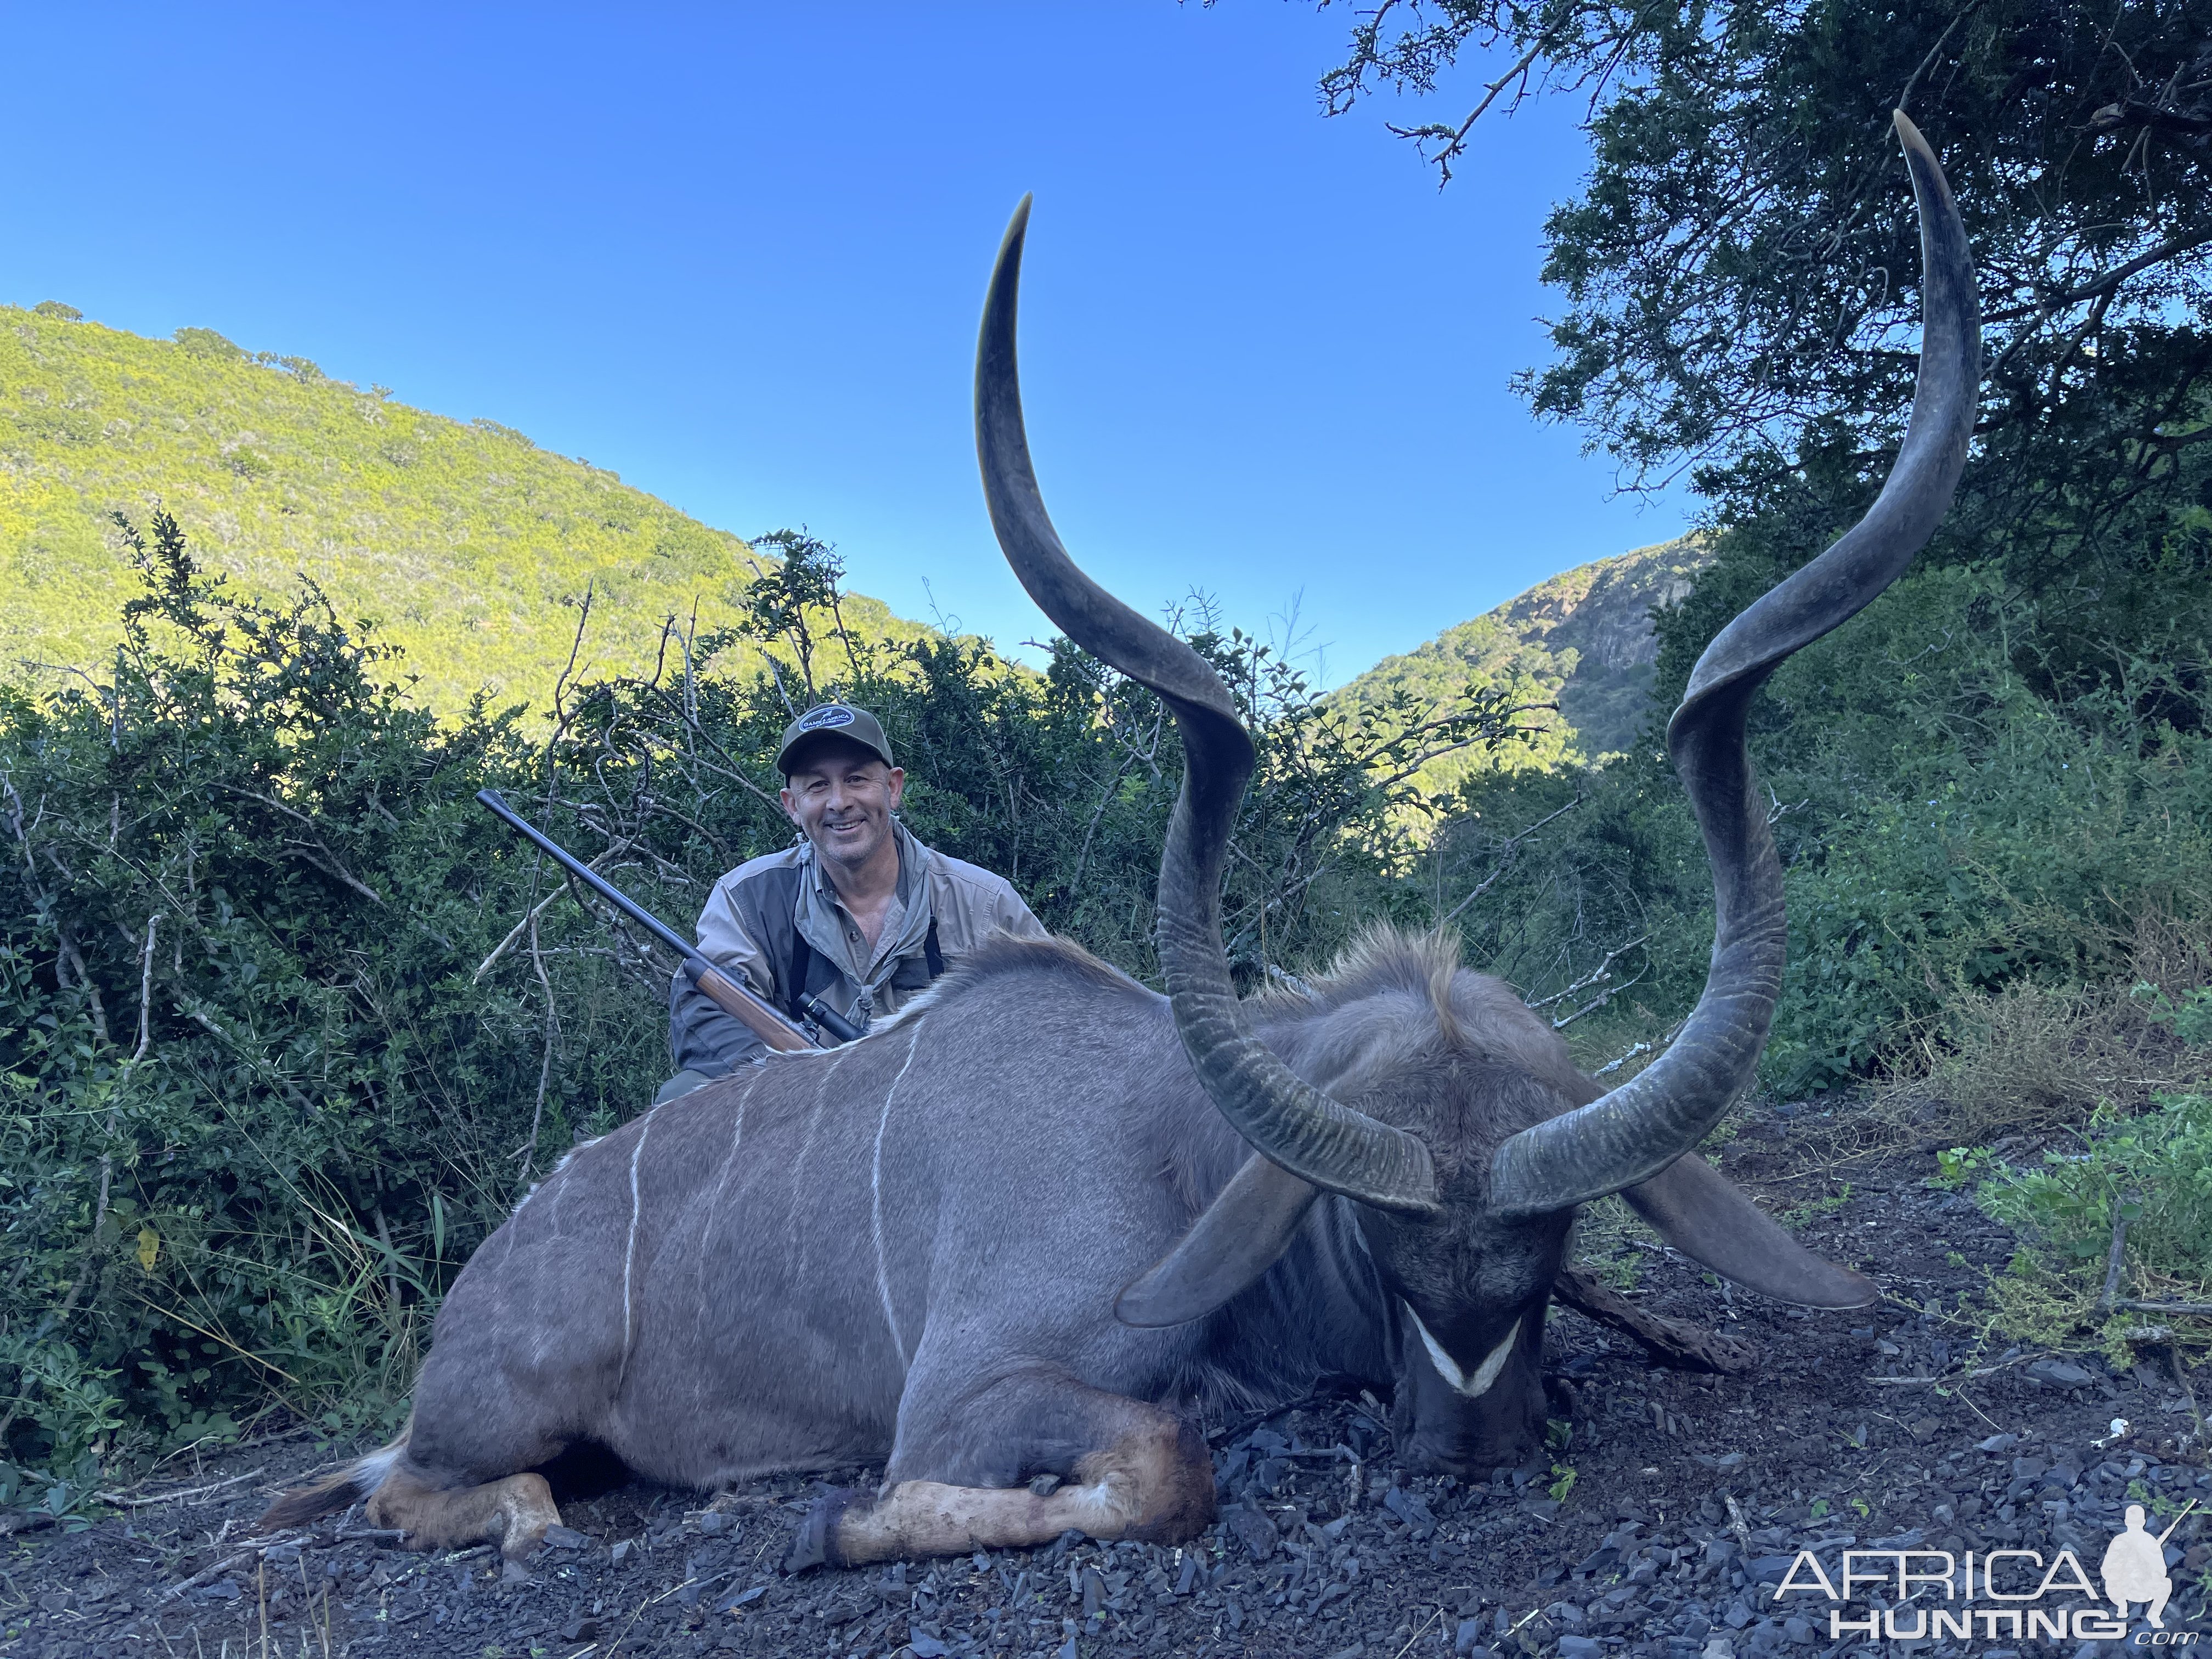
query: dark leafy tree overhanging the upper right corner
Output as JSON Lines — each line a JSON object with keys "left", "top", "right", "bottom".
{"left": 1323, "top": 0, "right": 2212, "bottom": 686}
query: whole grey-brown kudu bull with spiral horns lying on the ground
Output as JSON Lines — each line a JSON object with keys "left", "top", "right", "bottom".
{"left": 270, "top": 115, "right": 1980, "bottom": 1564}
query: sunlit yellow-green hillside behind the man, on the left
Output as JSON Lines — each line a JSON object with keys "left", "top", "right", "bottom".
{"left": 0, "top": 301, "right": 924, "bottom": 710}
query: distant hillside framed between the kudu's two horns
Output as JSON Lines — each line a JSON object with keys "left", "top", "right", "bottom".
{"left": 1338, "top": 538, "right": 1706, "bottom": 789}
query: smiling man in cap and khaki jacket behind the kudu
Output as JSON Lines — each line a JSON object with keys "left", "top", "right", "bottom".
{"left": 654, "top": 703, "right": 1046, "bottom": 1102}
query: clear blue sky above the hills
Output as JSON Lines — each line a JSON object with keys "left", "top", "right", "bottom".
{"left": 0, "top": 0, "right": 1690, "bottom": 681}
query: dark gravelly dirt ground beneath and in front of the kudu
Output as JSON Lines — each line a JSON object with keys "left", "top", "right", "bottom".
{"left": 0, "top": 1108, "right": 2212, "bottom": 1659}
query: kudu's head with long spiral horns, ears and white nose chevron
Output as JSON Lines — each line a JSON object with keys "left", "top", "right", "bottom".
{"left": 975, "top": 113, "right": 1982, "bottom": 1475}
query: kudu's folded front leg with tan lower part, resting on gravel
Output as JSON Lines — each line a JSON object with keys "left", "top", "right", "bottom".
{"left": 783, "top": 1376, "right": 1215, "bottom": 1573}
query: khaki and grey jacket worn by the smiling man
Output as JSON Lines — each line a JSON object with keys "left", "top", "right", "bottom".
{"left": 668, "top": 821, "right": 1046, "bottom": 1077}
